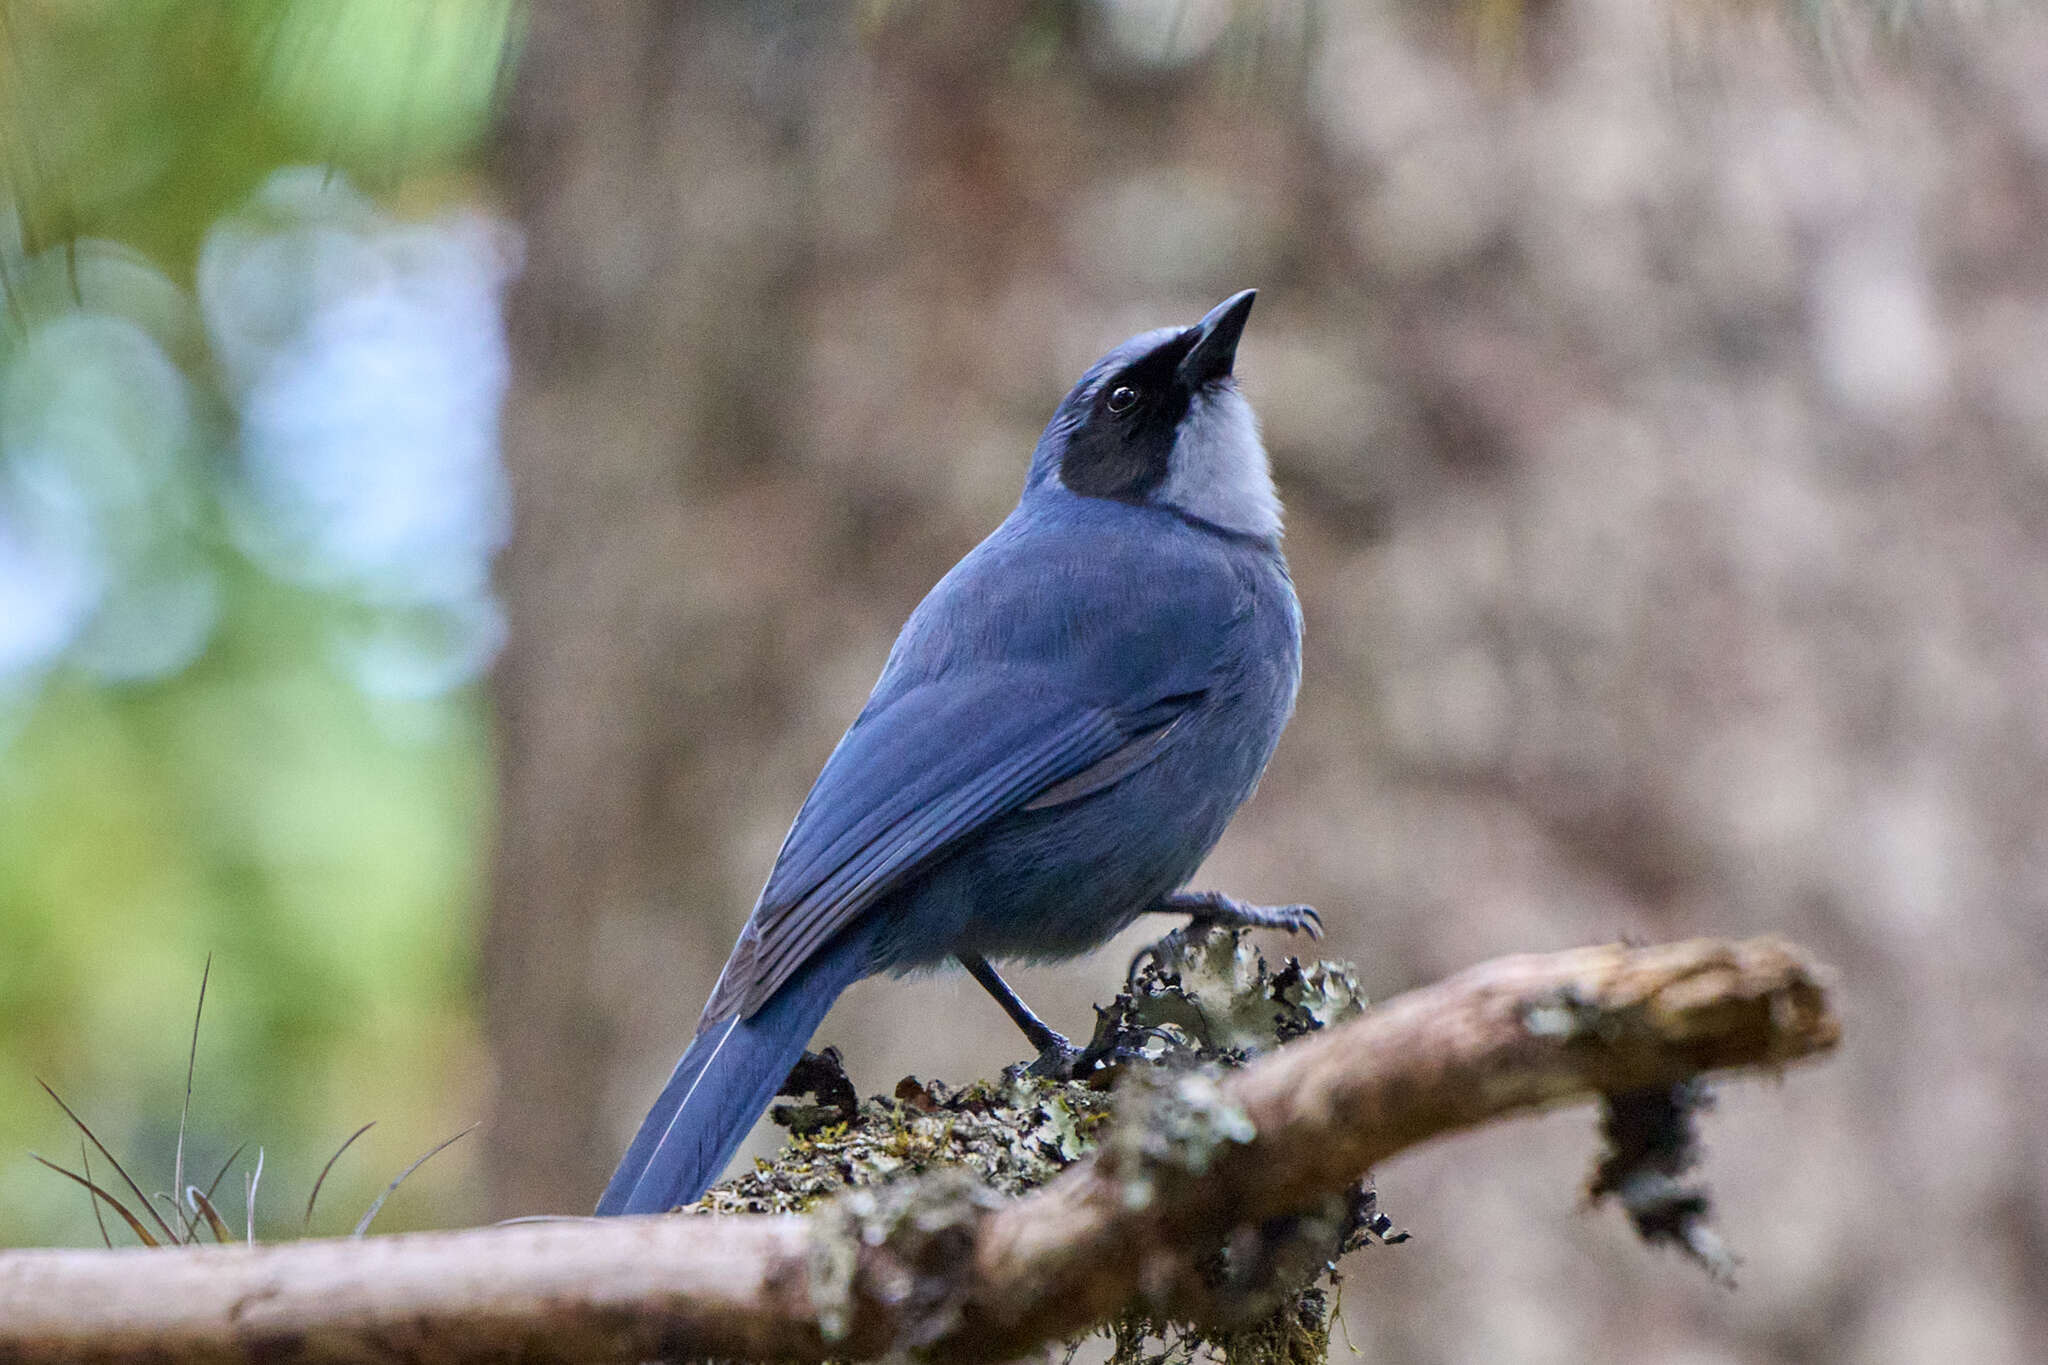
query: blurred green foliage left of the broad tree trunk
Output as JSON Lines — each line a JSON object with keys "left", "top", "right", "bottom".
{"left": 0, "top": 0, "right": 518, "bottom": 1244}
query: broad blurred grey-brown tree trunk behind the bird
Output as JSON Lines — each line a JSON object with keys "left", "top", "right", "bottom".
{"left": 471, "top": 0, "right": 2048, "bottom": 1361}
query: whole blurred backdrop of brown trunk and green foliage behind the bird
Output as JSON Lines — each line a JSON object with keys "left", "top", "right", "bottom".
{"left": 0, "top": 0, "right": 2048, "bottom": 1365}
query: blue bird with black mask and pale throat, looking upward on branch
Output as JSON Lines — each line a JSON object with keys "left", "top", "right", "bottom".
{"left": 596, "top": 289, "right": 1321, "bottom": 1216}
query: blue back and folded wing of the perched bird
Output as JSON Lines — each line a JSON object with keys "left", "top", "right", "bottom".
{"left": 702, "top": 505, "right": 1249, "bottom": 1023}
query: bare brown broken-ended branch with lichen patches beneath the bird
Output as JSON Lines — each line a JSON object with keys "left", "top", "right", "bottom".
{"left": 0, "top": 939, "right": 1839, "bottom": 1363}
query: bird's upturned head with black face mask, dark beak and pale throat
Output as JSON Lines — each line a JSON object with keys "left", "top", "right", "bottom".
{"left": 1026, "top": 289, "right": 1280, "bottom": 538}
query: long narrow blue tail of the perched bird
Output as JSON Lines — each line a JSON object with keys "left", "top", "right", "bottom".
{"left": 598, "top": 933, "right": 868, "bottom": 1218}
